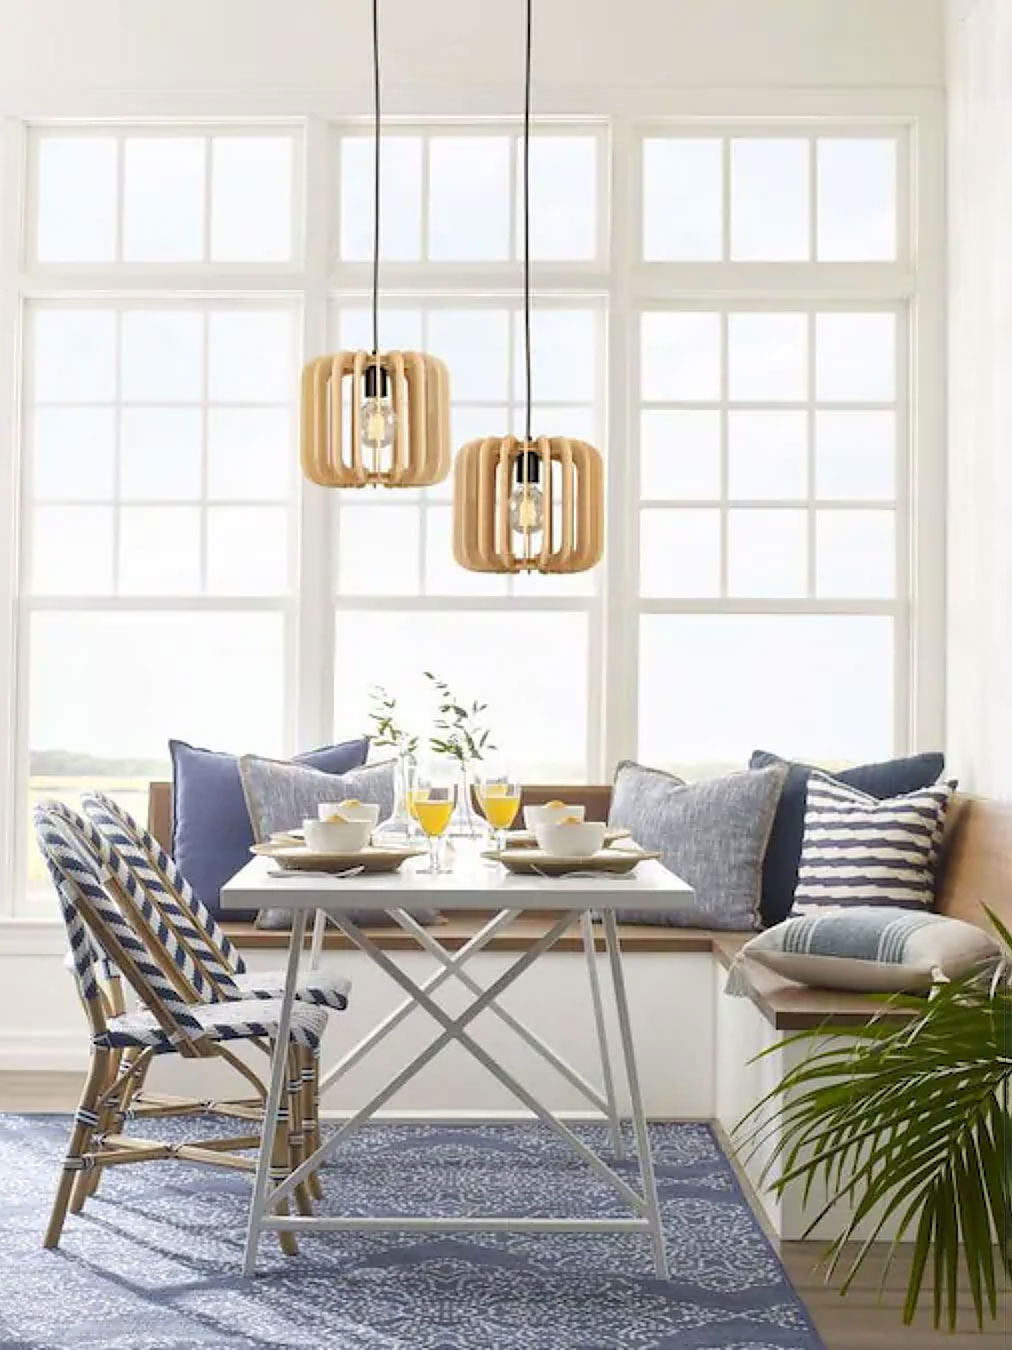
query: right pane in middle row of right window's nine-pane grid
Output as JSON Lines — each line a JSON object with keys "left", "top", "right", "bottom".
{"left": 815, "top": 412, "right": 896, "bottom": 501}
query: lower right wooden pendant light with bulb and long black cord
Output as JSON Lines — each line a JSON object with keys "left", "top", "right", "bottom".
{"left": 453, "top": 0, "right": 605, "bottom": 572}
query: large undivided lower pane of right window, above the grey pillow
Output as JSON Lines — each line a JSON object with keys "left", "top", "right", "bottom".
{"left": 640, "top": 614, "right": 895, "bottom": 778}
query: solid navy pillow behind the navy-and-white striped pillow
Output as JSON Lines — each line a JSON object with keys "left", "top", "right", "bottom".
{"left": 749, "top": 751, "right": 945, "bottom": 927}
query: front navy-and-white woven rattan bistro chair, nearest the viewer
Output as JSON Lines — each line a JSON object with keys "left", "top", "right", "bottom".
{"left": 35, "top": 802, "right": 327, "bottom": 1253}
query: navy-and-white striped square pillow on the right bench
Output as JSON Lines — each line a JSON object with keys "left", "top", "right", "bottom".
{"left": 791, "top": 772, "right": 953, "bottom": 915}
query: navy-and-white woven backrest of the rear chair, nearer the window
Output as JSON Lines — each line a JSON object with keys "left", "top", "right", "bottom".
{"left": 82, "top": 792, "right": 246, "bottom": 999}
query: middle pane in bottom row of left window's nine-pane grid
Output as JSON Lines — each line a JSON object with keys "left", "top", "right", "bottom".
{"left": 119, "top": 506, "right": 200, "bottom": 595}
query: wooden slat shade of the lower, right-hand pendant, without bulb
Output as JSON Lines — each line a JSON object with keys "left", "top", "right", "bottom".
{"left": 453, "top": 436, "right": 605, "bottom": 572}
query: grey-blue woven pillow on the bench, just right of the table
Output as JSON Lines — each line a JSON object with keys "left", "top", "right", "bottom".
{"left": 609, "top": 761, "right": 787, "bottom": 932}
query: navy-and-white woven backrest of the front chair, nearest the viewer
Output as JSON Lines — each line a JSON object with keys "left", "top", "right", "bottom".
{"left": 35, "top": 802, "right": 204, "bottom": 1040}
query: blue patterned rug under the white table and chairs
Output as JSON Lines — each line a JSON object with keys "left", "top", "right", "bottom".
{"left": 0, "top": 1115, "right": 822, "bottom": 1350}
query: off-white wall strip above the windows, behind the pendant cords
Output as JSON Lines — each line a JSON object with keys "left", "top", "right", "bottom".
{"left": 0, "top": 0, "right": 945, "bottom": 113}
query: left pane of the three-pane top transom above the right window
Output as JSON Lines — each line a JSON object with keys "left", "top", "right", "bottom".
{"left": 644, "top": 136, "right": 723, "bottom": 262}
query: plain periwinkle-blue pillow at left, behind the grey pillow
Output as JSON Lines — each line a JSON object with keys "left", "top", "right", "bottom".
{"left": 169, "top": 737, "right": 368, "bottom": 919}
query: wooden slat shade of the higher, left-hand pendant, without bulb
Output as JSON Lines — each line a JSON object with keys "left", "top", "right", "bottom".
{"left": 301, "top": 351, "right": 451, "bottom": 487}
